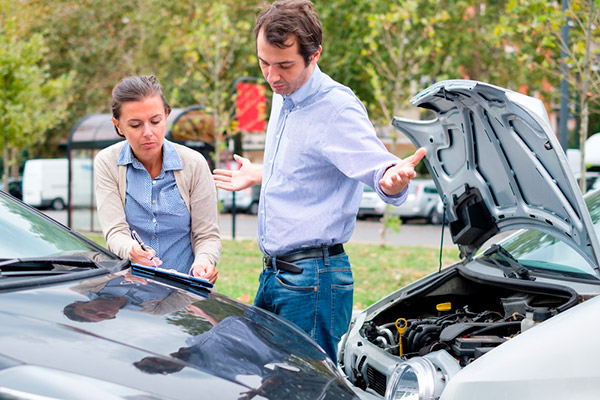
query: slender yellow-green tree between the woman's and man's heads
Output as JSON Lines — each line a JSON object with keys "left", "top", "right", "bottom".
{"left": 172, "top": 0, "right": 257, "bottom": 165}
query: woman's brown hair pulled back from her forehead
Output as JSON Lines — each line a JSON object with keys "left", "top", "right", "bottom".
{"left": 111, "top": 75, "right": 171, "bottom": 136}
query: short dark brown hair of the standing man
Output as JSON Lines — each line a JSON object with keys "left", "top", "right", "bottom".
{"left": 254, "top": 0, "right": 322, "bottom": 65}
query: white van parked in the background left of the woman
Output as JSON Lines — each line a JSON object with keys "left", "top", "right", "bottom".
{"left": 23, "top": 158, "right": 92, "bottom": 210}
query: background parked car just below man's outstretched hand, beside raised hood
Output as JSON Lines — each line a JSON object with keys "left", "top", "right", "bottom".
{"left": 389, "top": 179, "right": 441, "bottom": 224}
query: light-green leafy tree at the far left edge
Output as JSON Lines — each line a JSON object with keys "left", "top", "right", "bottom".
{"left": 0, "top": 2, "right": 71, "bottom": 187}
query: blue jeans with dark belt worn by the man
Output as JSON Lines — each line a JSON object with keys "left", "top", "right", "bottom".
{"left": 254, "top": 253, "right": 354, "bottom": 363}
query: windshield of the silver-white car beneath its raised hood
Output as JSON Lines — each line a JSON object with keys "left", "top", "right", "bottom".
{"left": 501, "top": 191, "right": 600, "bottom": 279}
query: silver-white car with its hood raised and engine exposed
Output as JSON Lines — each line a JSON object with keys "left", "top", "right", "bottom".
{"left": 338, "top": 81, "right": 600, "bottom": 400}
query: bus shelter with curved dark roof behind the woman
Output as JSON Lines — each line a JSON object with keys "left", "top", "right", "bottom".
{"left": 67, "top": 105, "right": 215, "bottom": 232}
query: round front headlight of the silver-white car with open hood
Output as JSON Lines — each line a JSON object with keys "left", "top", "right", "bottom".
{"left": 385, "top": 350, "right": 460, "bottom": 400}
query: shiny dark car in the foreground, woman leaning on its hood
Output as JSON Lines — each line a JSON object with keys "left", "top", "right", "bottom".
{"left": 0, "top": 192, "right": 357, "bottom": 400}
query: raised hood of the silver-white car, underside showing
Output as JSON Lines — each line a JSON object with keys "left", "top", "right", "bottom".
{"left": 392, "top": 80, "right": 600, "bottom": 270}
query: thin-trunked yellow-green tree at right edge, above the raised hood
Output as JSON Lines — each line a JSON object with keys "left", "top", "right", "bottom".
{"left": 497, "top": 0, "right": 600, "bottom": 192}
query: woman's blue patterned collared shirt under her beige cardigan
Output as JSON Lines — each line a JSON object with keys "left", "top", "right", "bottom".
{"left": 117, "top": 140, "right": 194, "bottom": 273}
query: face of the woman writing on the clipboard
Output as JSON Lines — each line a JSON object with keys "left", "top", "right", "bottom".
{"left": 113, "top": 96, "right": 167, "bottom": 162}
